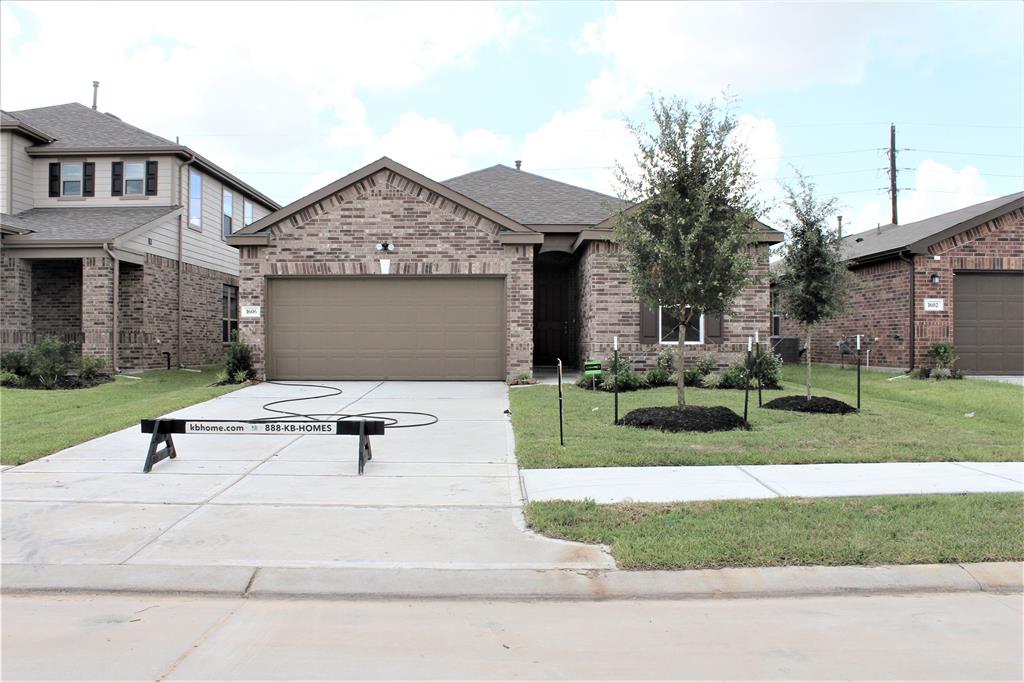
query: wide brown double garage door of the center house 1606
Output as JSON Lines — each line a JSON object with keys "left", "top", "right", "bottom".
{"left": 266, "top": 276, "right": 505, "bottom": 380}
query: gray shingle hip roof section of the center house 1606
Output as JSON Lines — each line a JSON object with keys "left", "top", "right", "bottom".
{"left": 441, "top": 165, "right": 622, "bottom": 225}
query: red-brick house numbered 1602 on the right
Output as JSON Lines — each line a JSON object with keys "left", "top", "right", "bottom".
{"left": 779, "top": 193, "right": 1024, "bottom": 375}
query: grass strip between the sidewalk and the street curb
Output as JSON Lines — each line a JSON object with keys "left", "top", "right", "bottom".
{"left": 526, "top": 494, "right": 1024, "bottom": 569}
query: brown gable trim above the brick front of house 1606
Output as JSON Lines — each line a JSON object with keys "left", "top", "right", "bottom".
{"left": 227, "top": 157, "right": 542, "bottom": 246}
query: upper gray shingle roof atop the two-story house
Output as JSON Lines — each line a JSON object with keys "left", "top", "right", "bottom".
{"left": 5, "top": 102, "right": 178, "bottom": 148}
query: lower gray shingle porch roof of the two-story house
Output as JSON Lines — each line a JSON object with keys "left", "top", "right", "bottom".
{"left": 0, "top": 206, "right": 179, "bottom": 242}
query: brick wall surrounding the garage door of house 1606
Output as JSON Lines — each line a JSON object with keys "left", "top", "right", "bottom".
{"left": 239, "top": 170, "right": 534, "bottom": 376}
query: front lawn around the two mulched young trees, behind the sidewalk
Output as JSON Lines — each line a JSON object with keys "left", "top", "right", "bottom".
{"left": 510, "top": 366, "right": 1024, "bottom": 469}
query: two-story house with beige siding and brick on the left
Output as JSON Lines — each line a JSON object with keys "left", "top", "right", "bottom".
{"left": 0, "top": 103, "right": 280, "bottom": 370}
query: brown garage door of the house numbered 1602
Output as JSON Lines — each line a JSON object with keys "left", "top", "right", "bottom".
{"left": 953, "top": 272, "right": 1024, "bottom": 374}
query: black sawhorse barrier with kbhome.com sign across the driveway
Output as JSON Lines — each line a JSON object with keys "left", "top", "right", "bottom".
{"left": 141, "top": 419, "right": 385, "bottom": 476}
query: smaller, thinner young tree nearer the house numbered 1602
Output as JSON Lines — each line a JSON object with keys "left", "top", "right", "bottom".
{"left": 778, "top": 173, "right": 849, "bottom": 400}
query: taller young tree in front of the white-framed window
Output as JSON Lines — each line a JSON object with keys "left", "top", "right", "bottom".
{"left": 614, "top": 98, "right": 757, "bottom": 407}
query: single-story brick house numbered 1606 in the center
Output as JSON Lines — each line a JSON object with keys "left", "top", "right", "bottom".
{"left": 227, "top": 158, "right": 782, "bottom": 379}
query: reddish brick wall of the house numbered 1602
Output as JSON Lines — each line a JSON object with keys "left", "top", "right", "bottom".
{"left": 781, "top": 210, "right": 1024, "bottom": 369}
